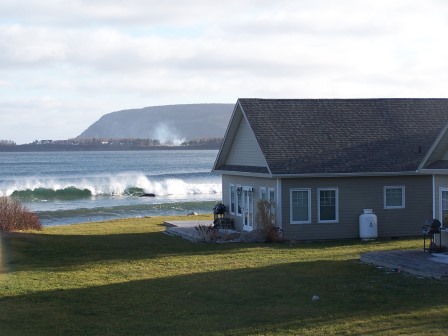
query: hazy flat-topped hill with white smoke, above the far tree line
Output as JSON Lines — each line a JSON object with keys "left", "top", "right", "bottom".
{"left": 77, "top": 104, "right": 234, "bottom": 143}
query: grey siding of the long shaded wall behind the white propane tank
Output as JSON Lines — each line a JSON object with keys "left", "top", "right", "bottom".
{"left": 281, "top": 176, "right": 433, "bottom": 240}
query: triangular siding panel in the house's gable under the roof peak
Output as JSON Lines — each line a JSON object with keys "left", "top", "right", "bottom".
{"left": 226, "top": 118, "right": 267, "bottom": 167}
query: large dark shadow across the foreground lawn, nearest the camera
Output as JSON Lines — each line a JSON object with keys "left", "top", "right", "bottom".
{"left": 0, "top": 261, "right": 448, "bottom": 336}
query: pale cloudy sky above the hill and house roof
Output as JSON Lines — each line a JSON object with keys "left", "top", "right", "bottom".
{"left": 0, "top": 0, "right": 448, "bottom": 144}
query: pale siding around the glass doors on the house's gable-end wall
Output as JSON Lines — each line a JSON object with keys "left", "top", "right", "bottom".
{"left": 222, "top": 174, "right": 276, "bottom": 230}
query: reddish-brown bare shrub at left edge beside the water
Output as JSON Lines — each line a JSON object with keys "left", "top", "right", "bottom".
{"left": 0, "top": 197, "right": 42, "bottom": 231}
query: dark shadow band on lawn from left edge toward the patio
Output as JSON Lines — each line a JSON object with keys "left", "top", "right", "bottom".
{"left": 3, "top": 232, "right": 220, "bottom": 271}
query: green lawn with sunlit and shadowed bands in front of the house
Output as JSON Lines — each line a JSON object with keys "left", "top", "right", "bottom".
{"left": 0, "top": 217, "right": 448, "bottom": 336}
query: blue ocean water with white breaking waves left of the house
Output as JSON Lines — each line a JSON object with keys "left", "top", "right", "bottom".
{"left": 0, "top": 150, "right": 222, "bottom": 226}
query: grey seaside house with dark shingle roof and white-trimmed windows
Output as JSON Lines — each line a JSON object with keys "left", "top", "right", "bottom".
{"left": 213, "top": 99, "right": 448, "bottom": 240}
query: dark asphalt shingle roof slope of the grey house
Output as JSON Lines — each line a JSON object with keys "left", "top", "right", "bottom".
{"left": 238, "top": 98, "right": 448, "bottom": 174}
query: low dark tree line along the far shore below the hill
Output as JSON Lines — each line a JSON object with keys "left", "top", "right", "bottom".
{"left": 0, "top": 138, "right": 223, "bottom": 152}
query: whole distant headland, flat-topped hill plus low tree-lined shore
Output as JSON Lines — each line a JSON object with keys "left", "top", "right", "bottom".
{"left": 0, "top": 104, "right": 234, "bottom": 152}
